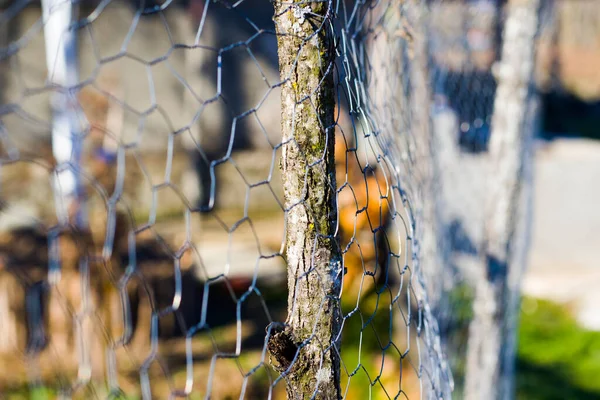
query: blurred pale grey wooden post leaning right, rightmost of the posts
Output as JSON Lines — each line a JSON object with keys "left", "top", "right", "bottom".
{"left": 465, "top": 0, "right": 539, "bottom": 399}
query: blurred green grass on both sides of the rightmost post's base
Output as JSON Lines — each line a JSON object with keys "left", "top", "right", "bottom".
{"left": 445, "top": 284, "right": 600, "bottom": 400}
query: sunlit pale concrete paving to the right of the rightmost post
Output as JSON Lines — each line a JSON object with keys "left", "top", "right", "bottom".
{"left": 523, "top": 139, "right": 600, "bottom": 330}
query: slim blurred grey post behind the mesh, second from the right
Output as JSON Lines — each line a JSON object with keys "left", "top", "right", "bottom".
{"left": 405, "top": 0, "right": 453, "bottom": 398}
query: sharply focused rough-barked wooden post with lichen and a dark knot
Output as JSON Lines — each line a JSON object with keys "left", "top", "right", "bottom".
{"left": 268, "top": 0, "right": 342, "bottom": 399}
